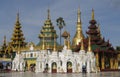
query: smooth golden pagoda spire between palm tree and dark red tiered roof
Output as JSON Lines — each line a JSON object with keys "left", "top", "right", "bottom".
{"left": 72, "top": 9, "right": 84, "bottom": 46}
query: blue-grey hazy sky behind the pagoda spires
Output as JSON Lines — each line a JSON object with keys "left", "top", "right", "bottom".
{"left": 0, "top": 0, "right": 120, "bottom": 47}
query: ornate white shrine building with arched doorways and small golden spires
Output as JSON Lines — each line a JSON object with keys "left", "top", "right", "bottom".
{"left": 12, "top": 36, "right": 98, "bottom": 73}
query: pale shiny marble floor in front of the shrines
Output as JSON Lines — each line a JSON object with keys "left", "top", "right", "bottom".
{"left": 0, "top": 72, "right": 120, "bottom": 77}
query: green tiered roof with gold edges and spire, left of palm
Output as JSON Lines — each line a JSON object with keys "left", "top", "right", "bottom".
{"left": 38, "top": 9, "right": 58, "bottom": 47}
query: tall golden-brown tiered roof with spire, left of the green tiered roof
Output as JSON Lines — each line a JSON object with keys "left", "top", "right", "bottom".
{"left": 10, "top": 13, "right": 26, "bottom": 48}
